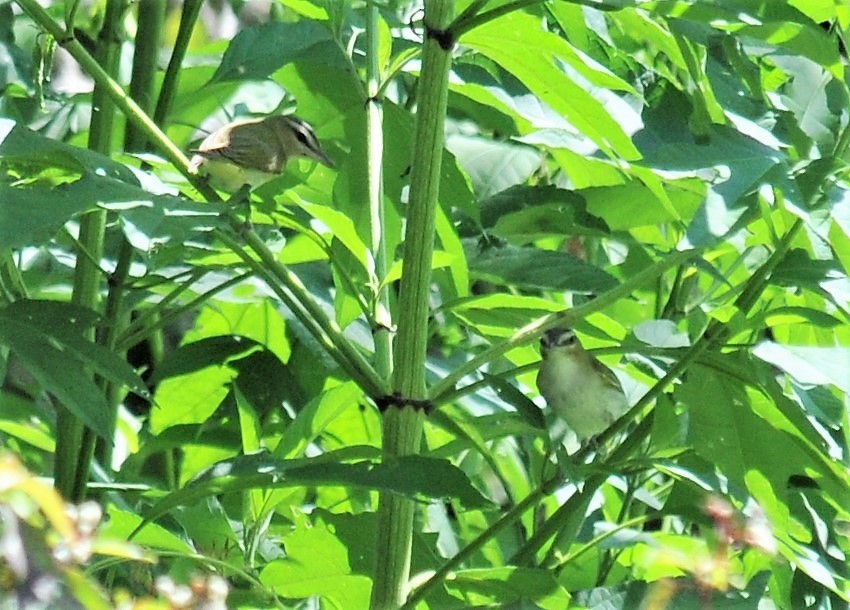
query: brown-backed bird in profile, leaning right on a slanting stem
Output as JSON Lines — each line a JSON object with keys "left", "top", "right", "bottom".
{"left": 190, "top": 115, "right": 334, "bottom": 192}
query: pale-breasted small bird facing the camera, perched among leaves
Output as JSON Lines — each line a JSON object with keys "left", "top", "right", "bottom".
{"left": 537, "top": 327, "right": 629, "bottom": 443}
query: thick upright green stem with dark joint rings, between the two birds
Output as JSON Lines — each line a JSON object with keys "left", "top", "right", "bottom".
{"left": 370, "top": 0, "right": 454, "bottom": 610}
